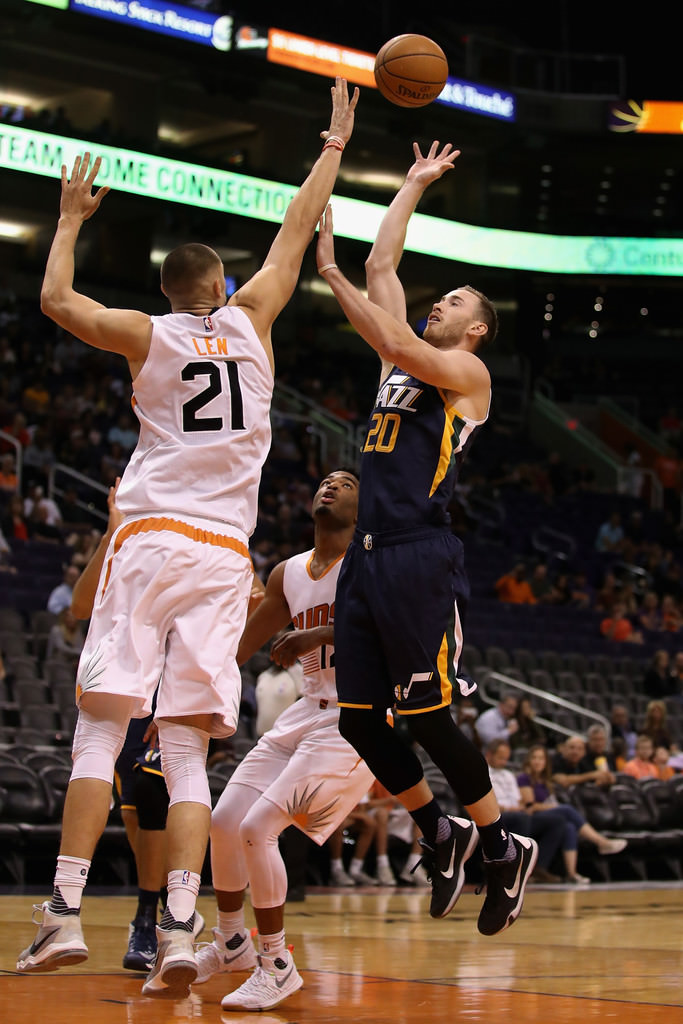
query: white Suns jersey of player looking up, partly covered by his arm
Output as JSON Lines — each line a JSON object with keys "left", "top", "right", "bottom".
{"left": 283, "top": 551, "right": 343, "bottom": 700}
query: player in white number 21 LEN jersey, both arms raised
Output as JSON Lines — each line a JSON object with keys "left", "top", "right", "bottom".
{"left": 17, "top": 79, "right": 357, "bottom": 997}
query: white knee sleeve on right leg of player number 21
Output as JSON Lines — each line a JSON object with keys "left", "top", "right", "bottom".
{"left": 158, "top": 719, "right": 211, "bottom": 810}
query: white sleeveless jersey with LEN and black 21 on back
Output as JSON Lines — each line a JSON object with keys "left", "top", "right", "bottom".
{"left": 117, "top": 305, "right": 273, "bottom": 537}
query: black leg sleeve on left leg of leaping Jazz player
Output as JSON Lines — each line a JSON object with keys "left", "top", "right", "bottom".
{"left": 339, "top": 708, "right": 424, "bottom": 795}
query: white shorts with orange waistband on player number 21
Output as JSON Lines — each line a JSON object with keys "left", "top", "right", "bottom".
{"left": 77, "top": 517, "right": 253, "bottom": 736}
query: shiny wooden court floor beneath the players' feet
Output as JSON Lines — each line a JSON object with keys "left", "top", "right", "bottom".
{"left": 0, "top": 883, "right": 683, "bottom": 1024}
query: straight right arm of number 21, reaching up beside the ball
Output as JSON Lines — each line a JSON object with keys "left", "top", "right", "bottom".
{"left": 229, "top": 78, "right": 358, "bottom": 344}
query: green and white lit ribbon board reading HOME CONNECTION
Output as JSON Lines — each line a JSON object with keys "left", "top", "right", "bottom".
{"left": 0, "top": 124, "right": 683, "bottom": 276}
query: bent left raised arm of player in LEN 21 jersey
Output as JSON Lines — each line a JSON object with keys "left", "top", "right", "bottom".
{"left": 40, "top": 153, "right": 152, "bottom": 371}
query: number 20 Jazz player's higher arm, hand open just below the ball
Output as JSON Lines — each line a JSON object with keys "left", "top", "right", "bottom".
{"left": 366, "top": 142, "right": 460, "bottom": 321}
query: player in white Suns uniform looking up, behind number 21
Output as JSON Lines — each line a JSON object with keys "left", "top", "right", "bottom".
{"left": 196, "top": 470, "right": 373, "bottom": 1010}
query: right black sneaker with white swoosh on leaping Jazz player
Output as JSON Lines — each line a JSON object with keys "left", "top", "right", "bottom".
{"left": 477, "top": 833, "right": 539, "bottom": 935}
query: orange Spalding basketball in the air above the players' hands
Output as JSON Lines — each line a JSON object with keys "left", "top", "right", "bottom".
{"left": 375, "top": 33, "right": 449, "bottom": 106}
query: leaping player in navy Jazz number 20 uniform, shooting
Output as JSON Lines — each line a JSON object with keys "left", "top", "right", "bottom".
{"left": 317, "top": 142, "right": 538, "bottom": 935}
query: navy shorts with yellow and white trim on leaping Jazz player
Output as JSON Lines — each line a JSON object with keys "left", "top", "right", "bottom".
{"left": 335, "top": 527, "right": 469, "bottom": 715}
